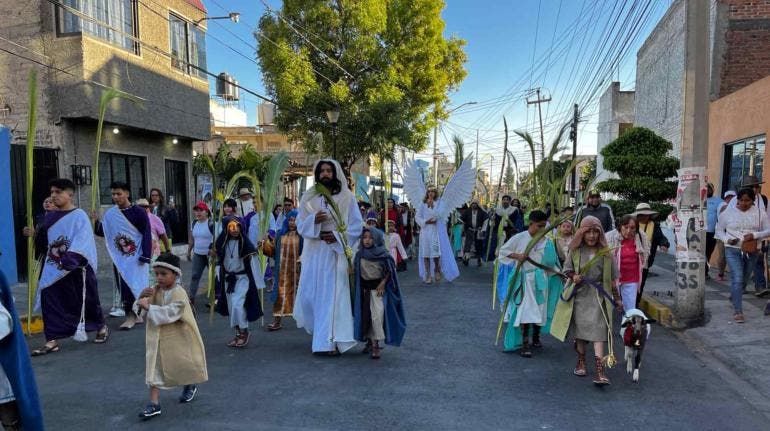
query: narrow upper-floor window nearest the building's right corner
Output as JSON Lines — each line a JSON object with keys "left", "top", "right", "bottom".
{"left": 168, "top": 14, "right": 207, "bottom": 78}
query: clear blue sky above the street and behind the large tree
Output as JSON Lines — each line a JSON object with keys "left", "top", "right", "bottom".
{"left": 205, "top": 0, "right": 671, "bottom": 179}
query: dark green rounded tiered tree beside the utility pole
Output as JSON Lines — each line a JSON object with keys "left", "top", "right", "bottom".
{"left": 597, "top": 127, "right": 679, "bottom": 202}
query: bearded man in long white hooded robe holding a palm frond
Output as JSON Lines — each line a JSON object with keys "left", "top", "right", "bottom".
{"left": 294, "top": 159, "right": 363, "bottom": 355}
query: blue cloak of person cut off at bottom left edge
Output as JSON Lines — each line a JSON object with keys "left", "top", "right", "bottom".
{"left": 0, "top": 272, "right": 44, "bottom": 431}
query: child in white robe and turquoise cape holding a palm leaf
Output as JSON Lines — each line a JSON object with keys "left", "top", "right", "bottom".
{"left": 498, "top": 210, "right": 562, "bottom": 358}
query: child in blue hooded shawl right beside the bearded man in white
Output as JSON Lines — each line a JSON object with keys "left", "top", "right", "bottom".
{"left": 353, "top": 227, "right": 406, "bottom": 359}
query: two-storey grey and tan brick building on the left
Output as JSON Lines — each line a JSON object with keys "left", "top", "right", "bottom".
{"left": 0, "top": 0, "right": 209, "bottom": 280}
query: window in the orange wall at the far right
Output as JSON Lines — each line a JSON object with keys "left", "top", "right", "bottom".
{"left": 722, "top": 135, "right": 765, "bottom": 191}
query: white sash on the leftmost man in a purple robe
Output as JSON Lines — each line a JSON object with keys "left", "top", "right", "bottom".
{"left": 38, "top": 208, "right": 97, "bottom": 292}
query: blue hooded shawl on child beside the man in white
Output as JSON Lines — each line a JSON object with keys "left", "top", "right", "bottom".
{"left": 353, "top": 228, "right": 406, "bottom": 346}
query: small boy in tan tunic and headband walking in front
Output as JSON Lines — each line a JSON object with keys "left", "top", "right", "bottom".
{"left": 133, "top": 253, "right": 208, "bottom": 419}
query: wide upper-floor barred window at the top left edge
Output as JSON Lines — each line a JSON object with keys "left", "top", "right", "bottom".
{"left": 56, "top": 0, "right": 139, "bottom": 54}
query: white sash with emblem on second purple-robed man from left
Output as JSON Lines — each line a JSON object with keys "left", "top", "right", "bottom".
{"left": 102, "top": 206, "right": 150, "bottom": 298}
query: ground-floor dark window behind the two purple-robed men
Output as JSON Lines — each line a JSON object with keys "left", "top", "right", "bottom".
{"left": 99, "top": 153, "right": 147, "bottom": 205}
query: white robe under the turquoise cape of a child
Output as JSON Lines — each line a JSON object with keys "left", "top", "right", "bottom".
{"left": 498, "top": 230, "right": 547, "bottom": 326}
